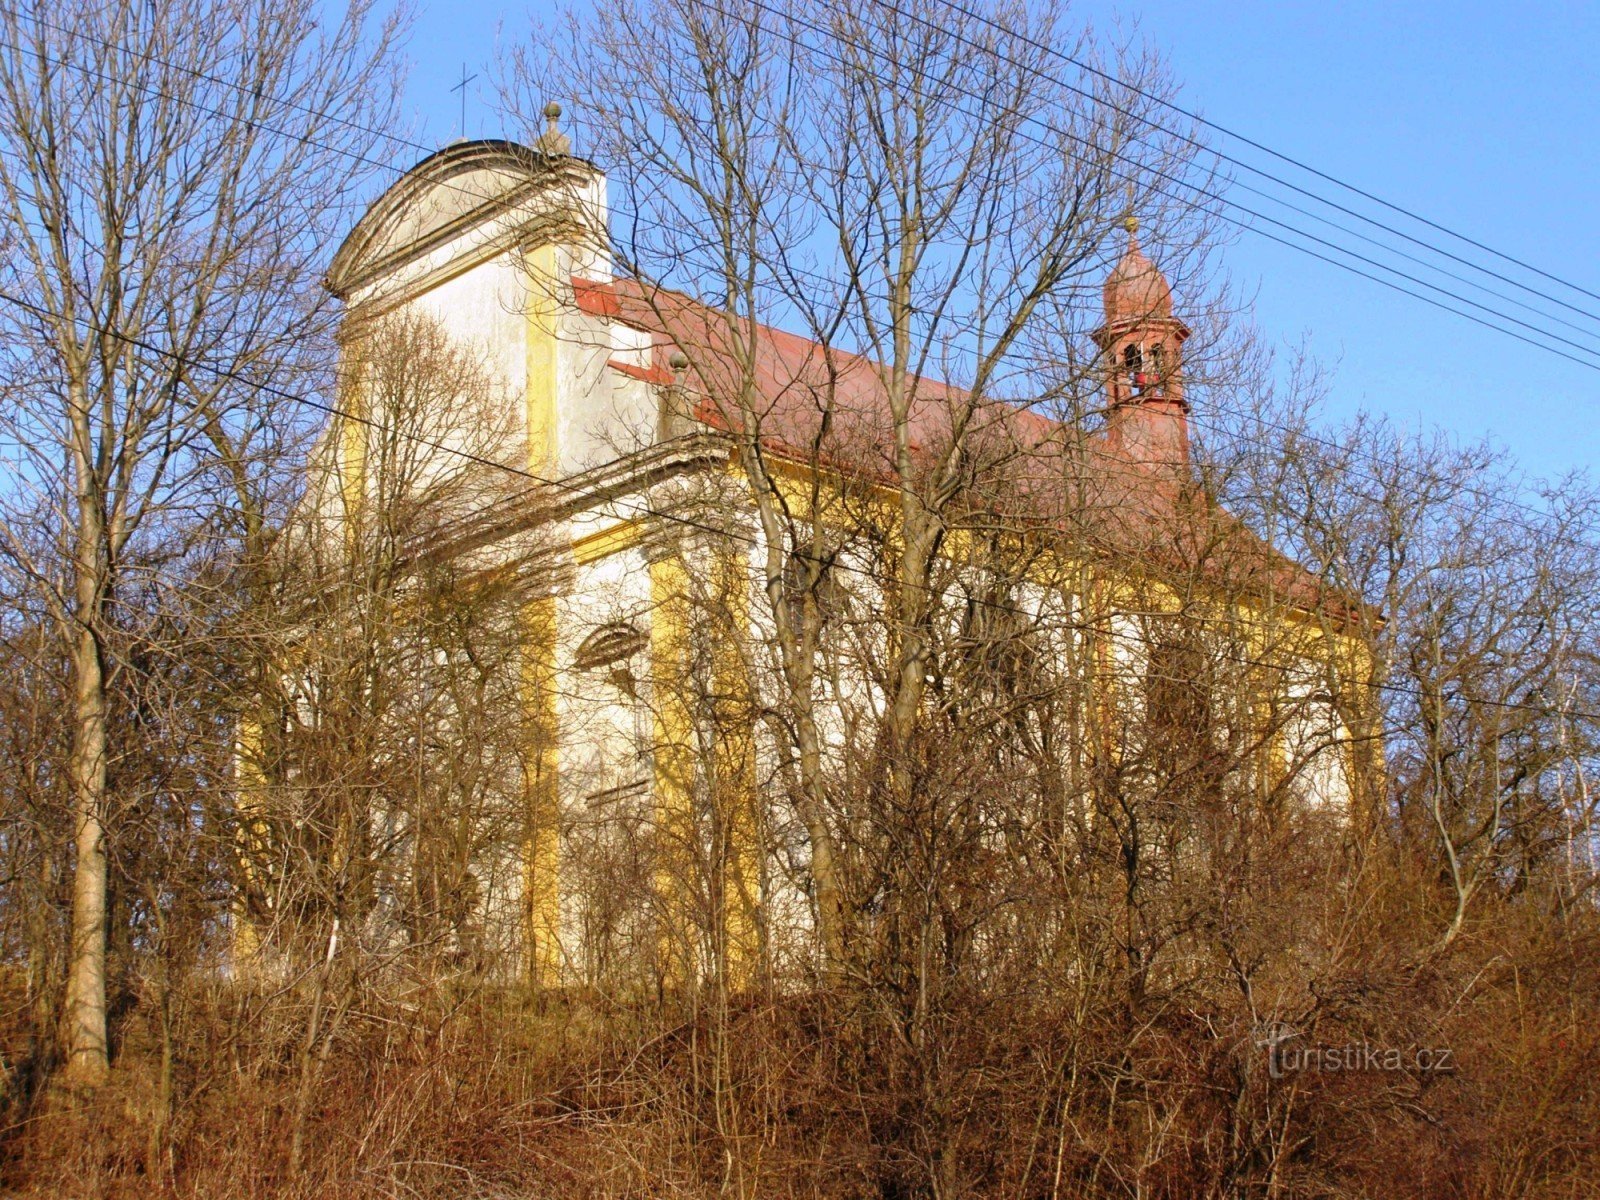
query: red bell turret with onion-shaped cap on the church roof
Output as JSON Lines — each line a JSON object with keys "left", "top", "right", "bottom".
{"left": 1094, "top": 214, "right": 1189, "bottom": 472}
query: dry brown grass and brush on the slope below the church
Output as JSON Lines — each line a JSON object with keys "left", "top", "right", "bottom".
{"left": 3, "top": 910, "right": 1600, "bottom": 1200}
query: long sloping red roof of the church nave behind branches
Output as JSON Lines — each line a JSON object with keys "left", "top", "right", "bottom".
{"left": 573, "top": 278, "right": 1365, "bottom": 621}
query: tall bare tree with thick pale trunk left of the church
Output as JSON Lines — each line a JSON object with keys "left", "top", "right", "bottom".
{"left": 0, "top": 0, "right": 403, "bottom": 1083}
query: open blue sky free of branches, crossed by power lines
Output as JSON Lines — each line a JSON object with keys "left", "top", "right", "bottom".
{"left": 384, "top": 0, "right": 1600, "bottom": 475}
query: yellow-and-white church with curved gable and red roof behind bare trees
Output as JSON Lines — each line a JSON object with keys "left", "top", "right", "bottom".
{"left": 278, "top": 117, "right": 1363, "bottom": 987}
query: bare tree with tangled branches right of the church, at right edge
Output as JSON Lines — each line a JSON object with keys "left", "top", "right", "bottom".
{"left": 1216, "top": 416, "right": 1597, "bottom": 949}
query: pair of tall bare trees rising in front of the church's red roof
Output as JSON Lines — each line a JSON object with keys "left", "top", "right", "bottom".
{"left": 509, "top": 3, "right": 1206, "bottom": 971}
